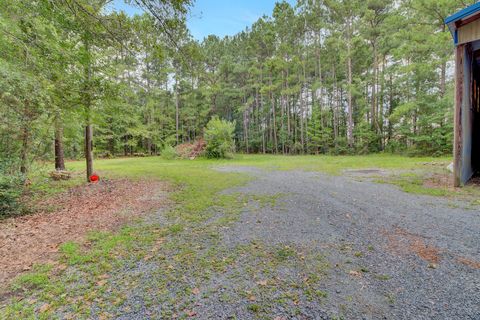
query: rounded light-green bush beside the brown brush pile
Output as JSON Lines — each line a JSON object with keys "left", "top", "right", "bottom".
{"left": 205, "top": 116, "right": 235, "bottom": 158}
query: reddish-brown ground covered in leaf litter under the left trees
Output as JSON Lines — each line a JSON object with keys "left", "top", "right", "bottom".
{"left": 0, "top": 180, "right": 169, "bottom": 289}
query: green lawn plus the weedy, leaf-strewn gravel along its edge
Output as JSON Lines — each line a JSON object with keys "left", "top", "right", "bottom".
{"left": 0, "top": 154, "right": 480, "bottom": 319}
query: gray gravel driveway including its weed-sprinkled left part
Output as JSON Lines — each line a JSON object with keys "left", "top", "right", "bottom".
{"left": 56, "top": 166, "right": 480, "bottom": 320}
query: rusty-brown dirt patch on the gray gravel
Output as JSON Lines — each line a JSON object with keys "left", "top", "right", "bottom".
{"left": 385, "top": 228, "right": 440, "bottom": 264}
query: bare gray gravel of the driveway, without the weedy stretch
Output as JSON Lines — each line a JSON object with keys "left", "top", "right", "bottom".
{"left": 205, "top": 167, "right": 480, "bottom": 319}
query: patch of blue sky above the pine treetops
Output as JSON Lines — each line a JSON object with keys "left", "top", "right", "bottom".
{"left": 114, "top": 0, "right": 296, "bottom": 40}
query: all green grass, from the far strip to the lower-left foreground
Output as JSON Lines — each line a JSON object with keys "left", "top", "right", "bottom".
{"left": 0, "top": 155, "right": 478, "bottom": 319}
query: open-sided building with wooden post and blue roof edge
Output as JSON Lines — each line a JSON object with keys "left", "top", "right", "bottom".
{"left": 445, "top": 2, "right": 480, "bottom": 186}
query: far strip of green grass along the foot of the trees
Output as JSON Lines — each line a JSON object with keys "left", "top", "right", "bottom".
{"left": 64, "top": 154, "right": 458, "bottom": 197}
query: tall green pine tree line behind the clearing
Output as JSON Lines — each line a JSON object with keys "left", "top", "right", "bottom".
{"left": 0, "top": 0, "right": 474, "bottom": 180}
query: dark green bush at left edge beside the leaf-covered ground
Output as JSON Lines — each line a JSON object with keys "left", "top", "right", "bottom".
{"left": 0, "top": 172, "right": 25, "bottom": 219}
